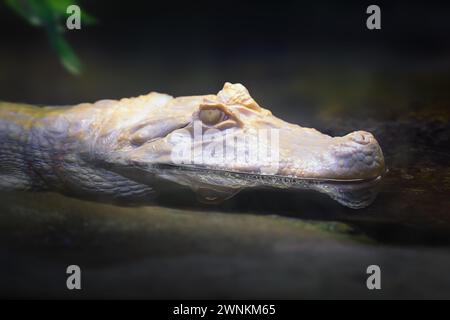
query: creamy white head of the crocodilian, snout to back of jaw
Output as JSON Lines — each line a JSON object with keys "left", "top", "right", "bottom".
{"left": 95, "top": 83, "right": 385, "bottom": 205}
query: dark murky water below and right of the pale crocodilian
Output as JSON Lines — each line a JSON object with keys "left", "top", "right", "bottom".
{"left": 0, "top": 109, "right": 450, "bottom": 298}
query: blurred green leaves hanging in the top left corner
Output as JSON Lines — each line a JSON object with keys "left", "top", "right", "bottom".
{"left": 5, "top": 0, "right": 96, "bottom": 75}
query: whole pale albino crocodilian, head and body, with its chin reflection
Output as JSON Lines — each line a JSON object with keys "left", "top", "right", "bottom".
{"left": 0, "top": 83, "right": 385, "bottom": 208}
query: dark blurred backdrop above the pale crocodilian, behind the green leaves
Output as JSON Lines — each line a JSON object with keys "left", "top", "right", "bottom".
{"left": 0, "top": 0, "right": 450, "bottom": 123}
